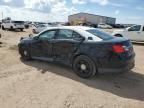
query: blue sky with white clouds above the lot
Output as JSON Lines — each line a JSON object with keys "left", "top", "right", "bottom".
{"left": 0, "top": 0, "right": 144, "bottom": 24}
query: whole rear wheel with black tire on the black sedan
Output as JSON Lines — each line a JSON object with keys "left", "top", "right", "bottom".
{"left": 73, "top": 55, "right": 96, "bottom": 78}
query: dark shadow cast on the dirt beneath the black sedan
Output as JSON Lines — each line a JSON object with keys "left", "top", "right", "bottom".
{"left": 21, "top": 60, "right": 144, "bottom": 101}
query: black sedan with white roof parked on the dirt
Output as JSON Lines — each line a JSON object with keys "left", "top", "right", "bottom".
{"left": 18, "top": 26, "right": 135, "bottom": 78}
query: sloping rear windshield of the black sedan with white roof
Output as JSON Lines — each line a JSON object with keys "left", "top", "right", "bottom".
{"left": 87, "top": 29, "right": 114, "bottom": 40}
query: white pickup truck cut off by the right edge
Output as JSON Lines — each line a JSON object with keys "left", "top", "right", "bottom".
{"left": 113, "top": 25, "right": 144, "bottom": 41}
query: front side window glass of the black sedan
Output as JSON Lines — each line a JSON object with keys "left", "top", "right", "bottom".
{"left": 39, "top": 30, "right": 56, "bottom": 40}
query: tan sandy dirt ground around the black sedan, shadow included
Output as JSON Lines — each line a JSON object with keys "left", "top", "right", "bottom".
{"left": 0, "top": 30, "right": 144, "bottom": 108}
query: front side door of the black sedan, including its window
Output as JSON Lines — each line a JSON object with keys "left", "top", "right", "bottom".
{"left": 31, "top": 30, "right": 56, "bottom": 58}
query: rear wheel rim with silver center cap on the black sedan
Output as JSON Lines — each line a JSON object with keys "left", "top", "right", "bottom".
{"left": 76, "top": 60, "right": 91, "bottom": 75}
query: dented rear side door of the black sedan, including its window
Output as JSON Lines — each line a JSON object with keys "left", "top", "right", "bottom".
{"left": 53, "top": 29, "right": 82, "bottom": 61}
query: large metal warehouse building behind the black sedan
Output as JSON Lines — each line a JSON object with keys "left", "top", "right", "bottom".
{"left": 68, "top": 12, "right": 116, "bottom": 25}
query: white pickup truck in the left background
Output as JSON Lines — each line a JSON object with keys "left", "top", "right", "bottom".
{"left": 2, "top": 20, "right": 25, "bottom": 31}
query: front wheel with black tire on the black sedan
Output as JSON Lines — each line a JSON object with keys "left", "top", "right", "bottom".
{"left": 19, "top": 48, "right": 31, "bottom": 61}
